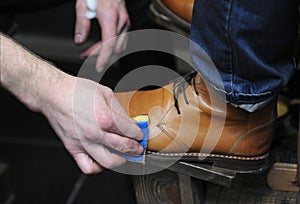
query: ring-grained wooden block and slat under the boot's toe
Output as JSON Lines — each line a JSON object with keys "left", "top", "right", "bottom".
{"left": 133, "top": 162, "right": 235, "bottom": 204}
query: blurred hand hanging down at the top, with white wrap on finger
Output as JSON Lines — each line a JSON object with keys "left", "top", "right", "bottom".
{"left": 74, "top": 0, "right": 130, "bottom": 71}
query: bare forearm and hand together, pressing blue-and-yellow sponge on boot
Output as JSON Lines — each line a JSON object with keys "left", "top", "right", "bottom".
{"left": 0, "top": 34, "right": 143, "bottom": 174}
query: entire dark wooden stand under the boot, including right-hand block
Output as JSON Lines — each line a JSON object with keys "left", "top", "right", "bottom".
{"left": 133, "top": 110, "right": 300, "bottom": 204}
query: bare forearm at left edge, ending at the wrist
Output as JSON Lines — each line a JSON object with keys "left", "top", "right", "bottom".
{"left": 0, "top": 35, "right": 74, "bottom": 112}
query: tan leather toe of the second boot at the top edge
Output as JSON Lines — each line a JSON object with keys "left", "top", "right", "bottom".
{"left": 161, "top": 0, "right": 194, "bottom": 22}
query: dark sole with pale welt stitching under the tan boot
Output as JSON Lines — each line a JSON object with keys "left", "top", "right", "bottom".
{"left": 146, "top": 151, "right": 271, "bottom": 173}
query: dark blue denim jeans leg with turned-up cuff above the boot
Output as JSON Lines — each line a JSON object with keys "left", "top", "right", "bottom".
{"left": 191, "top": 0, "right": 299, "bottom": 112}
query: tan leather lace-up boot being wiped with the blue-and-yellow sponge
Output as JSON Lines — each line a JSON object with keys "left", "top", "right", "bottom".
{"left": 115, "top": 72, "right": 277, "bottom": 172}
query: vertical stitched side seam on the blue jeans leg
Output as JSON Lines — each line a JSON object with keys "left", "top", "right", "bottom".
{"left": 224, "top": 0, "right": 234, "bottom": 94}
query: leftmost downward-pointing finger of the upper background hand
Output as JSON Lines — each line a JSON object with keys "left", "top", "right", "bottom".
{"left": 74, "top": 0, "right": 91, "bottom": 44}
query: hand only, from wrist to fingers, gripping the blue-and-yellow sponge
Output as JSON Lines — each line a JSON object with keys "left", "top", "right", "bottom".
{"left": 42, "top": 76, "right": 143, "bottom": 174}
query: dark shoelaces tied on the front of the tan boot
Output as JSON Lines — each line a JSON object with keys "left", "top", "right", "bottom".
{"left": 173, "top": 71, "right": 199, "bottom": 115}
